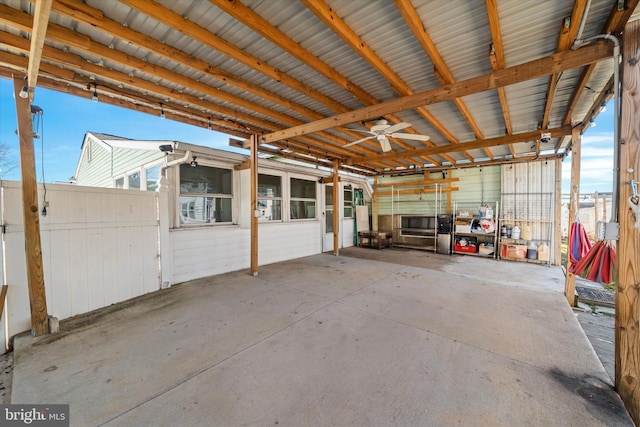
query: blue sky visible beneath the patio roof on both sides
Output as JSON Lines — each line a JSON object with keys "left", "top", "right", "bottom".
{"left": 0, "top": 78, "right": 613, "bottom": 194}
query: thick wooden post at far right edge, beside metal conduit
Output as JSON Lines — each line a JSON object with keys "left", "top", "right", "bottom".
{"left": 612, "top": 21, "right": 640, "bottom": 425}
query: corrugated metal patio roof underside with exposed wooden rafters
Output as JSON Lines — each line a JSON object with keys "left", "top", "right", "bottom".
{"left": 0, "top": 0, "right": 640, "bottom": 173}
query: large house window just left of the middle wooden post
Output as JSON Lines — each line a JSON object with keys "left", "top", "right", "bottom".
{"left": 179, "top": 164, "right": 233, "bottom": 224}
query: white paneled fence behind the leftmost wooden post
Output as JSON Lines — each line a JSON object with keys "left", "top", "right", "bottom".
{"left": 0, "top": 181, "right": 160, "bottom": 352}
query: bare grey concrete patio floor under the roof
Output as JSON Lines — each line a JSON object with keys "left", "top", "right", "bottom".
{"left": 11, "top": 248, "right": 633, "bottom": 426}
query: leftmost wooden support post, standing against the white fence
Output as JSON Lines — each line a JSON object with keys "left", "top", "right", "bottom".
{"left": 13, "top": 77, "right": 49, "bottom": 337}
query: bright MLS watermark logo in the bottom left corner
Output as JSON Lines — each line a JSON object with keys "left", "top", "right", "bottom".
{"left": 0, "top": 405, "right": 69, "bottom": 427}
